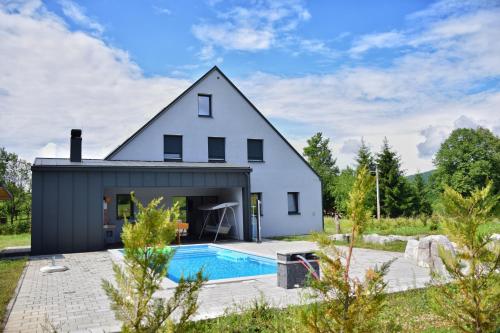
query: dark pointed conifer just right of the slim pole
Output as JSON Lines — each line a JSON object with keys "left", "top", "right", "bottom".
{"left": 377, "top": 138, "right": 410, "bottom": 217}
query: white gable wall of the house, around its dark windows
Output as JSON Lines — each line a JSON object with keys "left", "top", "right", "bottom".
{"left": 111, "top": 70, "right": 322, "bottom": 237}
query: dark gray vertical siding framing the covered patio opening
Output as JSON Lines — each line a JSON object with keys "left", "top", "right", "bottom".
{"left": 31, "top": 169, "right": 251, "bottom": 254}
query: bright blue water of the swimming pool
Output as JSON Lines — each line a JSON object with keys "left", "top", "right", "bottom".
{"left": 167, "top": 245, "right": 277, "bottom": 282}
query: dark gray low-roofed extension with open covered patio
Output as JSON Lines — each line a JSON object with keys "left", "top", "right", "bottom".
{"left": 31, "top": 158, "right": 252, "bottom": 254}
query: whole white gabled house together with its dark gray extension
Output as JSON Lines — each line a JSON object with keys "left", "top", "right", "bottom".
{"left": 33, "top": 67, "right": 323, "bottom": 252}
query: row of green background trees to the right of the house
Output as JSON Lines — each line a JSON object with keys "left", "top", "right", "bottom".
{"left": 304, "top": 128, "right": 500, "bottom": 217}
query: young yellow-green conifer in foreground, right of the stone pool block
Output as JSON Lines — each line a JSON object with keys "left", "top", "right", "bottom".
{"left": 302, "top": 167, "right": 390, "bottom": 333}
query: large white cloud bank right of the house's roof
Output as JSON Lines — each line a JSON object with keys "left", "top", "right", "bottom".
{"left": 240, "top": 2, "right": 500, "bottom": 172}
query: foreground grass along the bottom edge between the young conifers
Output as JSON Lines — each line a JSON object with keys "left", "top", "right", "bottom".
{"left": 187, "top": 289, "right": 455, "bottom": 333}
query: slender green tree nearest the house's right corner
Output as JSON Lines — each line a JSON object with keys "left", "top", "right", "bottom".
{"left": 304, "top": 132, "right": 339, "bottom": 212}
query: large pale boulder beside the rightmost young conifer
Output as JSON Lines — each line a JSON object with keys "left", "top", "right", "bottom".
{"left": 405, "top": 235, "right": 455, "bottom": 276}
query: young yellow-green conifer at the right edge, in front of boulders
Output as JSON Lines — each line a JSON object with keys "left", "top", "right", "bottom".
{"left": 433, "top": 183, "right": 500, "bottom": 333}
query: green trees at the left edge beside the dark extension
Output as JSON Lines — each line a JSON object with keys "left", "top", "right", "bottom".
{"left": 0, "top": 147, "right": 31, "bottom": 223}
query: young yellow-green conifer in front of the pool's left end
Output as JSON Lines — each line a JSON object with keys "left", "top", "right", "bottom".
{"left": 102, "top": 193, "right": 203, "bottom": 332}
